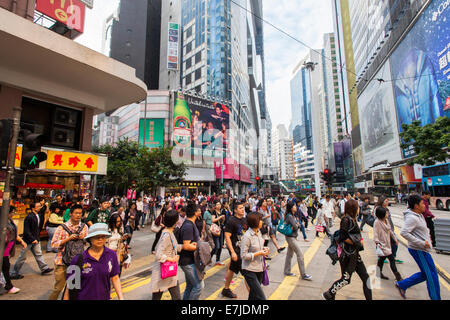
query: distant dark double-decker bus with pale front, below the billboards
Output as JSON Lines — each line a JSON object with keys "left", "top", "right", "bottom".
{"left": 355, "top": 170, "right": 397, "bottom": 204}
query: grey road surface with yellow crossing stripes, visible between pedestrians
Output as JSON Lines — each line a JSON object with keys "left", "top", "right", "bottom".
{"left": 0, "top": 205, "right": 450, "bottom": 300}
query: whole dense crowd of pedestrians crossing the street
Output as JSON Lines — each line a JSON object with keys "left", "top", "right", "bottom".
{"left": 2, "top": 193, "right": 440, "bottom": 300}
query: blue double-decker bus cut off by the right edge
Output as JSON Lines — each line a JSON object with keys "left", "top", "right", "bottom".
{"left": 422, "top": 163, "right": 450, "bottom": 210}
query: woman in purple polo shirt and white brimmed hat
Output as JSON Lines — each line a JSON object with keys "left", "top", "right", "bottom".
{"left": 64, "top": 223, "right": 124, "bottom": 300}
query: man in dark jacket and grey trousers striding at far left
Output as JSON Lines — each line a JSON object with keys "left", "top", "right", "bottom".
{"left": 10, "top": 202, "right": 53, "bottom": 279}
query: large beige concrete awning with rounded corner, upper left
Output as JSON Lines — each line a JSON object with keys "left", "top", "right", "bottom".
{"left": 0, "top": 8, "right": 147, "bottom": 113}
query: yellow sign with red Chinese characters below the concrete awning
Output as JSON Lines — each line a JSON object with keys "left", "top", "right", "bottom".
{"left": 45, "top": 150, "right": 98, "bottom": 172}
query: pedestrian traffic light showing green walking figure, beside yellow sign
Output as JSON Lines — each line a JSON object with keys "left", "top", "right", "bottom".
{"left": 19, "top": 129, "right": 47, "bottom": 170}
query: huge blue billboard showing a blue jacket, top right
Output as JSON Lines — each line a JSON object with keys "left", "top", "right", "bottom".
{"left": 391, "top": 0, "right": 450, "bottom": 158}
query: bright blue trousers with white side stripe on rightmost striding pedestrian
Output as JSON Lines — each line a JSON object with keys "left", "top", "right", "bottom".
{"left": 398, "top": 248, "right": 441, "bottom": 300}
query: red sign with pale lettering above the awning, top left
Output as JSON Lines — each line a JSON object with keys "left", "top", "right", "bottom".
{"left": 36, "top": 0, "right": 86, "bottom": 33}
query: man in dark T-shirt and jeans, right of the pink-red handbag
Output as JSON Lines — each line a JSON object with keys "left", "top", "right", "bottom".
{"left": 179, "top": 203, "right": 202, "bottom": 300}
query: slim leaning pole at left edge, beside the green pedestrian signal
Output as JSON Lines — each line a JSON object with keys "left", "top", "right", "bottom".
{"left": 0, "top": 107, "right": 22, "bottom": 270}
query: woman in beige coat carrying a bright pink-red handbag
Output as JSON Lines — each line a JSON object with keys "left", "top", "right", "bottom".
{"left": 150, "top": 210, "right": 183, "bottom": 300}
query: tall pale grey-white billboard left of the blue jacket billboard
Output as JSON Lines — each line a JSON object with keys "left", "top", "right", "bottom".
{"left": 358, "top": 61, "right": 401, "bottom": 170}
